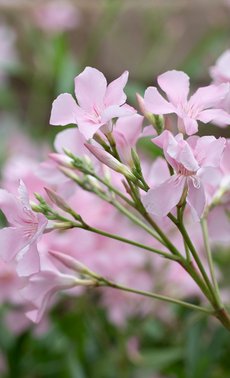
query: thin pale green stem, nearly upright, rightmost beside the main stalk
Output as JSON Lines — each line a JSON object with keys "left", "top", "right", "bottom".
{"left": 201, "top": 218, "right": 222, "bottom": 307}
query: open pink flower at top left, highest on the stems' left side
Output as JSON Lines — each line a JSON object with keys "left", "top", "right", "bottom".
{"left": 50, "top": 67, "right": 135, "bottom": 139}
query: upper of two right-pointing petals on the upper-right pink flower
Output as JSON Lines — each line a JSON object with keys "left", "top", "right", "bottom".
{"left": 189, "top": 83, "right": 229, "bottom": 110}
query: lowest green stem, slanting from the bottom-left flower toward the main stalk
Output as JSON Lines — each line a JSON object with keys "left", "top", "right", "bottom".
{"left": 102, "top": 280, "right": 214, "bottom": 315}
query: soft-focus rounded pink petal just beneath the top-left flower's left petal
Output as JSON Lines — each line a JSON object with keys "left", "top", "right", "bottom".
{"left": 54, "top": 127, "right": 86, "bottom": 156}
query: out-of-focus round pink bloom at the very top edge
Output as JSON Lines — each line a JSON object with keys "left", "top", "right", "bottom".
{"left": 33, "top": 0, "right": 81, "bottom": 33}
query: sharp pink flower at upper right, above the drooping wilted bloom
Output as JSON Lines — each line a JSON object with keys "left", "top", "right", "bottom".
{"left": 141, "top": 70, "right": 230, "bottom": 135}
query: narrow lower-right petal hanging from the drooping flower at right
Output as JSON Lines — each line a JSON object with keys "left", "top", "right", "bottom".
{"left": 187, "top": 180, "right": 206, "bottom": 218}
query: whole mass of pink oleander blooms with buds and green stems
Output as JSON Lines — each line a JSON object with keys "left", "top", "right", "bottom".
{"left": 0, "top": 53, "right": 230, "bottom": 328}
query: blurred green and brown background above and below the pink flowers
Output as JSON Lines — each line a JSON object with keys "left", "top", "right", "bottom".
{"left": 0, "top": 0, "right": 230, "bottom": 378}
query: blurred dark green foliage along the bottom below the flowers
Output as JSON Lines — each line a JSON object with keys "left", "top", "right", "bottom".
{"left": 0, "top": 296, "right": 230, "bottom": 378}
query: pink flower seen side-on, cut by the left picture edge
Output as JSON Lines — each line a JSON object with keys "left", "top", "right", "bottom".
{"left": 0, "top": 181, "right": 47, "bottom": 276}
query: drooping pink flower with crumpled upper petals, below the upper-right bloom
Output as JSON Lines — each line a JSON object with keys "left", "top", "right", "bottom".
{"left": 143, "top": 131, "right": 225, "bottom": 217}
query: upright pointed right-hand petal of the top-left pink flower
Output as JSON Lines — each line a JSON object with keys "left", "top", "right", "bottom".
{"left": 105, "top": 71, "right": 129, "bottom": 106}
